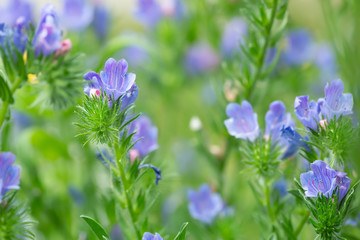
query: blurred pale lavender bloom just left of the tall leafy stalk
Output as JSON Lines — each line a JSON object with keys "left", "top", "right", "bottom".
{"left": 221, "top": 18, "right": 248, "bottom": 57}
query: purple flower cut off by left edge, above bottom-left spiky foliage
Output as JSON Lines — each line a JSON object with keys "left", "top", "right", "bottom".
{"left": 0, "top": 152, "right": 20, "bottom": 203}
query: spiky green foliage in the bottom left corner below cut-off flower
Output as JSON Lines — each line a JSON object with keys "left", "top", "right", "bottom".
{"left": 0, "top": 193, "right": 35, "bottom": 240}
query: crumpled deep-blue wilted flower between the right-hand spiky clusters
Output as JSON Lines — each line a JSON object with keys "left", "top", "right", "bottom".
{"left": 281, "top": 126, "right": 311, "bottom": 159}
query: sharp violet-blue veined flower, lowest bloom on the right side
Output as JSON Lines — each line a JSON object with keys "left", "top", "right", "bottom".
{"left": 300, "top": 160, "right": 351, "bottom": 201}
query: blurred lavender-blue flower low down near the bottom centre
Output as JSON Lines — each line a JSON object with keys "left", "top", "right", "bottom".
{"left": 188, "top": 184, "right": 224, "bottom": 224}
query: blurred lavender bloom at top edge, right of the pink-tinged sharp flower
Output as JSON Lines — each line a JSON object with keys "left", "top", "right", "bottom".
{"left": 61, "top": 0, "right": 94, "bottom": 31}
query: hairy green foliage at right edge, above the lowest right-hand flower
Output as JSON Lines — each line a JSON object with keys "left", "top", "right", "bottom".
{"left": 307, "top": 115, "right": 359, "bottom": 165}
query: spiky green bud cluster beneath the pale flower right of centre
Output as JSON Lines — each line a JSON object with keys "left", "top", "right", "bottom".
{"left": 241, "top": 138, "right": 281, "bottom": 178}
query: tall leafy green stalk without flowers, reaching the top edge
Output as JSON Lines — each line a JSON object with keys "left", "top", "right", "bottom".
{"left": 232, "top": 0, "right": 288, "bottom": 99}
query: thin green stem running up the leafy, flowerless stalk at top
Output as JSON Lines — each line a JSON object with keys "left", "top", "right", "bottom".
{"left": 246, "top": 0, "right": 278, "bottom": 100}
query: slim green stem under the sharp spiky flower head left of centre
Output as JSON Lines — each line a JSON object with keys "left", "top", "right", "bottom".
{"left": 115, "top": 145, "right": 141, "bottom": 239}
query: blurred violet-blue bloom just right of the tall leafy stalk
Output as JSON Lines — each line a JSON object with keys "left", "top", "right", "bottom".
{"left": 281, "top": 29, "right": 313, "bottom": 65}
